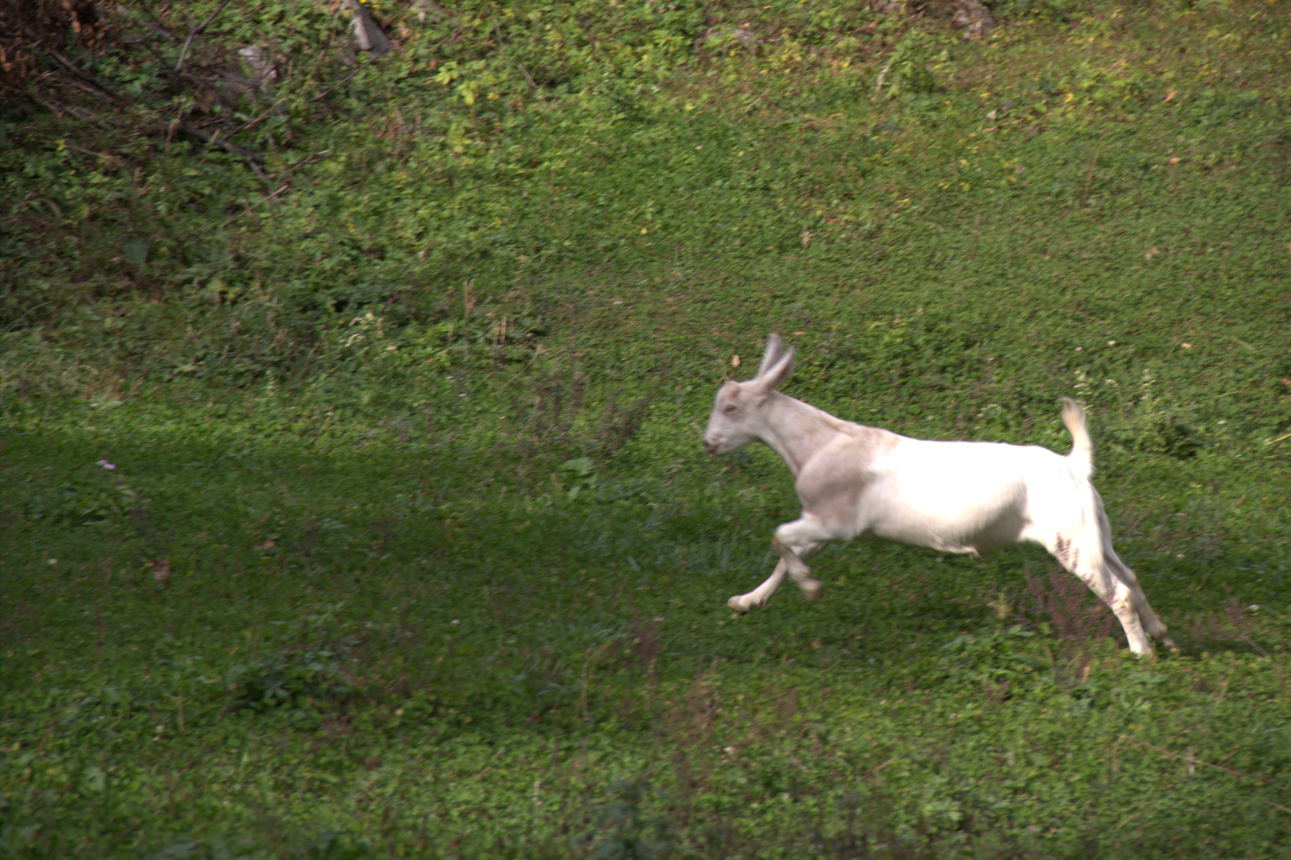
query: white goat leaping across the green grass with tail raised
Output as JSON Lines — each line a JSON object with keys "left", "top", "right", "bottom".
{"left": 704, "top": 334, "right": 1175, "bottom": 655}
